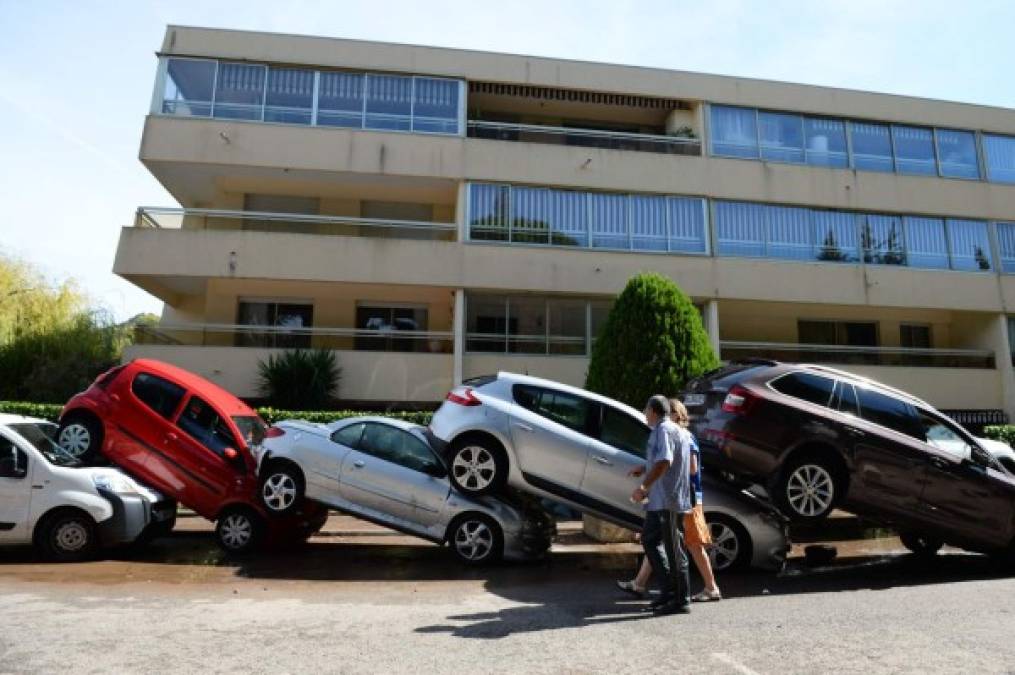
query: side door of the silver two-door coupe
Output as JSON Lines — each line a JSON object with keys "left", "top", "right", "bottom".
{"left": 339, "top": 422, "right": 451, "bottom": 531}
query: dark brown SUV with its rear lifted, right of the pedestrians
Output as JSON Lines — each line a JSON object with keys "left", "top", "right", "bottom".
{"left": 684, "top": 359, "right": 1015, "bottom": 553}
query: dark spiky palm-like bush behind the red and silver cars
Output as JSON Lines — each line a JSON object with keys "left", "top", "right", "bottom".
{"left": 258, "top": 349, "right": 342, "bottom": 410}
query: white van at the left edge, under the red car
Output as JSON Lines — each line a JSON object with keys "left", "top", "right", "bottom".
{"left": 0, "top": 414, "right": 176, "bottom": 560}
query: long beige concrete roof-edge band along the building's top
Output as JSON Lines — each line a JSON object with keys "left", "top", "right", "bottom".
{"left": 161, "top": 25, "right": 1015, "bottom": 133}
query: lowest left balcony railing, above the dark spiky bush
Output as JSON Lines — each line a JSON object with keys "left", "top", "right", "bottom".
{"left": 134, "top": 324, "right": 453, "bottom": 353}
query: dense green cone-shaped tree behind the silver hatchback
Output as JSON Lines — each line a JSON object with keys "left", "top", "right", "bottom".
{"left": 585, "top": 273, "right": 719, "bottom": 409}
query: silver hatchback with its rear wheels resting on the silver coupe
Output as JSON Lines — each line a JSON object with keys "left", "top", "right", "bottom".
{"left": 429, "top": 373, "right": 789, "bottom": 568}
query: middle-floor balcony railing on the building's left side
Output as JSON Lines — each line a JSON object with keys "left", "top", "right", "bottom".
{"left": 134, "top": 206, "right": 458, "bottom": 242}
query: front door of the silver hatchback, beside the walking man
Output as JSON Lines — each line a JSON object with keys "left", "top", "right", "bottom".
{"left": 582, "top": 404, "right": 650, "bottom": 525}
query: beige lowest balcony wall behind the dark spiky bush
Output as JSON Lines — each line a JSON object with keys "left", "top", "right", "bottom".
{"left": 124, "top": 345, "right": 451, "bottom": 403}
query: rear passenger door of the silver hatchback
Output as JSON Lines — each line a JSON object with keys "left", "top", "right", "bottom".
{"left": 510, "top": 385, "right": 594, "bottom": 495}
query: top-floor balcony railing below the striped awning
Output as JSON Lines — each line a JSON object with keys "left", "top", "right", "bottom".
{"left": 468, "top": 120, "right": 701, "bottom": 156}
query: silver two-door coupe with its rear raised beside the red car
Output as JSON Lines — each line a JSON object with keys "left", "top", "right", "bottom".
{"left": 258, "top": 417, "right": 554, "bottom": 564}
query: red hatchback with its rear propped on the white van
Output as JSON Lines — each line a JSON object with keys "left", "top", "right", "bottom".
{"left": 59, "top": 359, "right": 328, "bottom": 553}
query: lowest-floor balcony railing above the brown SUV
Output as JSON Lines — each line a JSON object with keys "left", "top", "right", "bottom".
{"left": 720, "top": 340, "right": 995, "bottom": 368}
